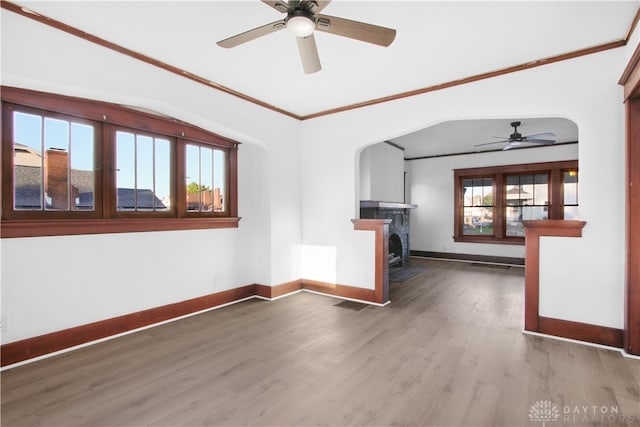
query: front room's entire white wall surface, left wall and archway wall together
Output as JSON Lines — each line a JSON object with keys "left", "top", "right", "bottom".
{"left": 1, "top": 5, "right": 632, "bottom": 343}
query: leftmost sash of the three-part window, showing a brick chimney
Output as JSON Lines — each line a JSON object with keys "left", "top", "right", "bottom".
{"left": 3, "top": 108, "right": 97, "bottom": 218}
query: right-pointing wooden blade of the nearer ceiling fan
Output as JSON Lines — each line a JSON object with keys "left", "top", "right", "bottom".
{"left": 316, "top": 15, "right": 396, "bottom": 47}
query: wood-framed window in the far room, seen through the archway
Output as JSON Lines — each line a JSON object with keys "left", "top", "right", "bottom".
{"left": 453, "top": 160, "right": 578, "bottom": 244}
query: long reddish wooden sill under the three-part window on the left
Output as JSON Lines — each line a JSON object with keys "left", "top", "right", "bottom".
{"left": 0, "top": 217, "right": 240, "bottom": 239}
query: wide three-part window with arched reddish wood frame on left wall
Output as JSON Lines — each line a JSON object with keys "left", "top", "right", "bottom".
{"left": 2, "top": 87, "right": 239, "bottom": 237}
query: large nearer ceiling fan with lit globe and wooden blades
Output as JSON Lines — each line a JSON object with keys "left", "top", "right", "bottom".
{"left": 218, "top": 0, "right": 396, "bottom": 74}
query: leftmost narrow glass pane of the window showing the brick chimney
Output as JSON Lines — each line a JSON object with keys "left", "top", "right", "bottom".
{"left": 13, "top": 112, "right": 44, "bottom": 210}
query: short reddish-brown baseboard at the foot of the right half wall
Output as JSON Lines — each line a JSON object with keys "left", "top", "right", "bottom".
{"left": 535, "top": 316, "right": 623, "bottom": 348}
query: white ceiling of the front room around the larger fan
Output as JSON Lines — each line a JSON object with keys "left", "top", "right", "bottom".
{"left": 11, "top": 0, "right": 639, "bottom": 118}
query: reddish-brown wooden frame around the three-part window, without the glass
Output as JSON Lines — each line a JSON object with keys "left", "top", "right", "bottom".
{"left": 0, "top": 86, "right": 240, "bottom": 238}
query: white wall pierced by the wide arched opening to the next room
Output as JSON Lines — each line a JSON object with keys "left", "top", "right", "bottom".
{"left": 302, "top": 49, "right": 626, "bottom": 328}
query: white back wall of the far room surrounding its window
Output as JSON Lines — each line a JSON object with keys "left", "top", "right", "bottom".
{"left": 407, "top": 144, "right": 582, "bottom": 258}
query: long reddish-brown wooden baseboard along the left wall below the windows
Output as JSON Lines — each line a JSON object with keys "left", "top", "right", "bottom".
{"left": 0, "top": 285, "right": 255, "bottom": 366}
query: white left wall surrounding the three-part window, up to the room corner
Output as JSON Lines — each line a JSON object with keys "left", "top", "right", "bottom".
{"left": 0, "top": 10, "right": 301, "bottom": 343}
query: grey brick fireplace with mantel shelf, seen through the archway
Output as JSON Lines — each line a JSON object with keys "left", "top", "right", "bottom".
{"left": 360, "top": 200, "right": 418, "bottom": 267}
